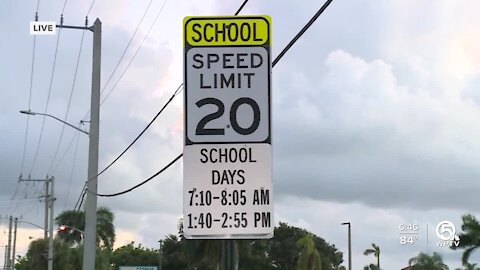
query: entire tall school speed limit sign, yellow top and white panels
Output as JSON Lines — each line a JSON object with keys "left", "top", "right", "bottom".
{"left": 183, "top": 16, "right": 274, "bottom": 238}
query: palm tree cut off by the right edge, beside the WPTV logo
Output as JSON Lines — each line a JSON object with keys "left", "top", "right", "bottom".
{"left": 451, "top": 214, "right": 480, "bottom": 265}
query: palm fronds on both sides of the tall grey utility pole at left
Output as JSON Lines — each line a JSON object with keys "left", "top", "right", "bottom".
{"left": 55, "top": 207, "right": 115, "bottom": 250}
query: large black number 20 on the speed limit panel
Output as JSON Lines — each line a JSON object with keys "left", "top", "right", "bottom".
{"left": 195, "top": 97, "right": 260, "bottom": 135}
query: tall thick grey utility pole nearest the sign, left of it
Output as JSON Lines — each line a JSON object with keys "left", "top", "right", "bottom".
{"left": 83, "top": 19, "right": 102, "bottom": 270}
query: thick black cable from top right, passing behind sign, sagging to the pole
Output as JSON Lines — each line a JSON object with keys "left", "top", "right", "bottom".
{"left": 88, "top": 0, "right": 332, "bottom": 197}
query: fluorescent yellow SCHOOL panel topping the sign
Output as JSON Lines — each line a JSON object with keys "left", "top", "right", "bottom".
{"left": 183, "top": 16, "right": 271, "bottom": 46}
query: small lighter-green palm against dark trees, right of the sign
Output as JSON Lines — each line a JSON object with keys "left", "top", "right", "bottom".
{"left": 297, "top": 233, "right": 322, "bottom": 270}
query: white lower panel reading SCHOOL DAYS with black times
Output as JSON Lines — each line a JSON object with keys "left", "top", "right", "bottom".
{"left": 183, "top": 144, "right": 274, "bottom": 238}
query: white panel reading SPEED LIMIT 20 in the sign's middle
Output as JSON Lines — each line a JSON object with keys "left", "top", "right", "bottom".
{"left": 185, "top": 46, "right": 270, "bottom": 143}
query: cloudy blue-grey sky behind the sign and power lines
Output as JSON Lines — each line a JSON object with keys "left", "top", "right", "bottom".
{"left": 0, "top": 0, "right": 480, "bottom": 269}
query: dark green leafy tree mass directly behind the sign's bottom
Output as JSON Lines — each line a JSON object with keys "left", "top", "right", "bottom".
{"left": 162, "top": 219, "right": 343, "bottom": 270}
